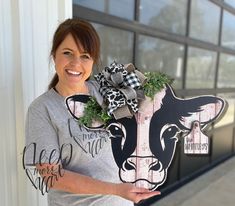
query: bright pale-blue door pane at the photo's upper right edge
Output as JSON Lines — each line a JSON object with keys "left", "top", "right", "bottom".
{"left": 222, "top": 11, "right": 235, "bottom": 49}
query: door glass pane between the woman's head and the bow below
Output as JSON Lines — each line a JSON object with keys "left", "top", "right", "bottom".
{"left": 93, "top": 24, "right": 134, "bottom": 68}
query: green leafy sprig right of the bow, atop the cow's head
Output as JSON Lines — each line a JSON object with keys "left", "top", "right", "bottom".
{"left": 143, "top": 72, "right": 173, "bottom": 99}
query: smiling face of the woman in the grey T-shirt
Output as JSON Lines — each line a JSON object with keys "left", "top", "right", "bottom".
{"left": 54, "top": 34, "right": 94, "bottom": 90}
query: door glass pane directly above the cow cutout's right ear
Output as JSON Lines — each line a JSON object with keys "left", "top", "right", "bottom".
{"left": 186, "top": 47, "right": 217, "bottom": 88}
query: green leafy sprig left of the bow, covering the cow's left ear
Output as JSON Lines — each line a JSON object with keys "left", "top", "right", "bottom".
{"left": 79, "top": 97, "right": 111, "bottom": 127}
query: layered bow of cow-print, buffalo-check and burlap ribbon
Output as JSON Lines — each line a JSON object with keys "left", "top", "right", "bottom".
{"left": 94, "top": 62, "right": 144, "bottom": 119}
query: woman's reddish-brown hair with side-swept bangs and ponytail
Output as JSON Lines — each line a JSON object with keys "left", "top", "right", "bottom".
{"left": 48, "top": 19, "right": 100, "bottom": 89}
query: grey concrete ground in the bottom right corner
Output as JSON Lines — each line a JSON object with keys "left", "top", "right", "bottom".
{"left": 151, "top": 157, "right": 235, "bottom": 206}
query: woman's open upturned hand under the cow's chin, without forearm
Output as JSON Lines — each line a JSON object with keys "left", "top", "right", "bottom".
{"left": 116, "top": 183, "right": 161, "bottom": 203}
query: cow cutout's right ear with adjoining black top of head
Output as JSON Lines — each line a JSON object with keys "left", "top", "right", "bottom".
{"left": 162, "top": 85, "right": 226, "bottom": 129}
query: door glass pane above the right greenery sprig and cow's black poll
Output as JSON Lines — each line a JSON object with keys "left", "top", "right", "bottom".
{"left": 136, "top": 35, "right": 184, "bottom": 88}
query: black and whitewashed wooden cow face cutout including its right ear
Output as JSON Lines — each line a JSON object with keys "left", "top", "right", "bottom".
{"left": 64, "top": 86, "right": 225, "bottom": 190}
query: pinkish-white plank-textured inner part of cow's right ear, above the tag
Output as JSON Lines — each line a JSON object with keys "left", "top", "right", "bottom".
{"left": 180, "top": 97, "right": 225, "bottom": 129}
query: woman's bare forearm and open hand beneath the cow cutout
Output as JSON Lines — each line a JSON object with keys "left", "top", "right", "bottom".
{"left": 36, "top": 164, "right": 160, "bottom": 203}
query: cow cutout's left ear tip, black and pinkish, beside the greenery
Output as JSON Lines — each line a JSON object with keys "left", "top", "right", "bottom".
{"left": 65, "top": 94, "right": 91, "bottom": 120}
